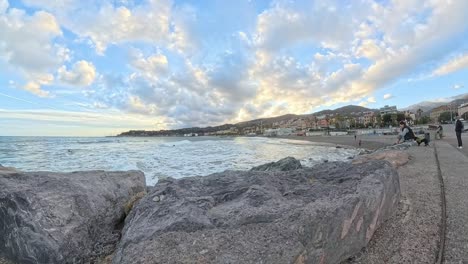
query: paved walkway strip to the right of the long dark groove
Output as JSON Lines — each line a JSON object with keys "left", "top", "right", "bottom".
{"left": 435, "top": 140, "right": 468, "bottom": 263}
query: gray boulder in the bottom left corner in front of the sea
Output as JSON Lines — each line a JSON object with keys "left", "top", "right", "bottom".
{"left": 0, "top": 167, "right": 146, "bottom": 264}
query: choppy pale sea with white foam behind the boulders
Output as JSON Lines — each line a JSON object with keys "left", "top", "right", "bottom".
{"left": 0, "top": 137, "right": 359, "bottom": 185}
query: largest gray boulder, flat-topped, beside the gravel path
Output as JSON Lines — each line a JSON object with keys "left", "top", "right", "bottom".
{"left": 113, "top": 160, "right": 400, "bottom": 264}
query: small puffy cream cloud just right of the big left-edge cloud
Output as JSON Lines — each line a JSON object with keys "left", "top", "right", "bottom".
{"left": 57, "top": 60, "right": 96, "bottom": 86}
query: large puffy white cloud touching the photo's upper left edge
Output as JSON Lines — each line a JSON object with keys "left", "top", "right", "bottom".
{"left": 0, "top": 3, "right": 67, "bottom": 97}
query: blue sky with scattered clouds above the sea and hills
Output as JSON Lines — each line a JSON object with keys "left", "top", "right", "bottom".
{"left": 0, "top": 0, "right": 468, "bottom": 136}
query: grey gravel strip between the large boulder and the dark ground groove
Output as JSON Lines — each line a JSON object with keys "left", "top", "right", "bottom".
{"left": 345, "top": 147, "right": 441, "bottom": 264}
